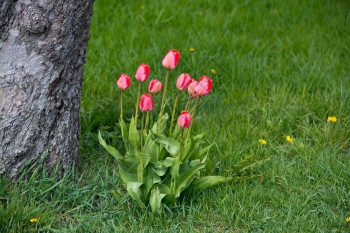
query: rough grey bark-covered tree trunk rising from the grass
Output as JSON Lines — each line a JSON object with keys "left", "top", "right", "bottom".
{"left": 0, "top": 0, "right": 93, "bottom": 177}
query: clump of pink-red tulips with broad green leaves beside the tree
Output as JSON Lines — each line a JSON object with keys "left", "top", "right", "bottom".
{"left": 98, "top": 50, "right": 232, "bottom": 214}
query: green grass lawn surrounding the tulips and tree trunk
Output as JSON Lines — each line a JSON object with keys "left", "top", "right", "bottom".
{"left": 0, "top": 0, "right": 350, "bottom": 232}
